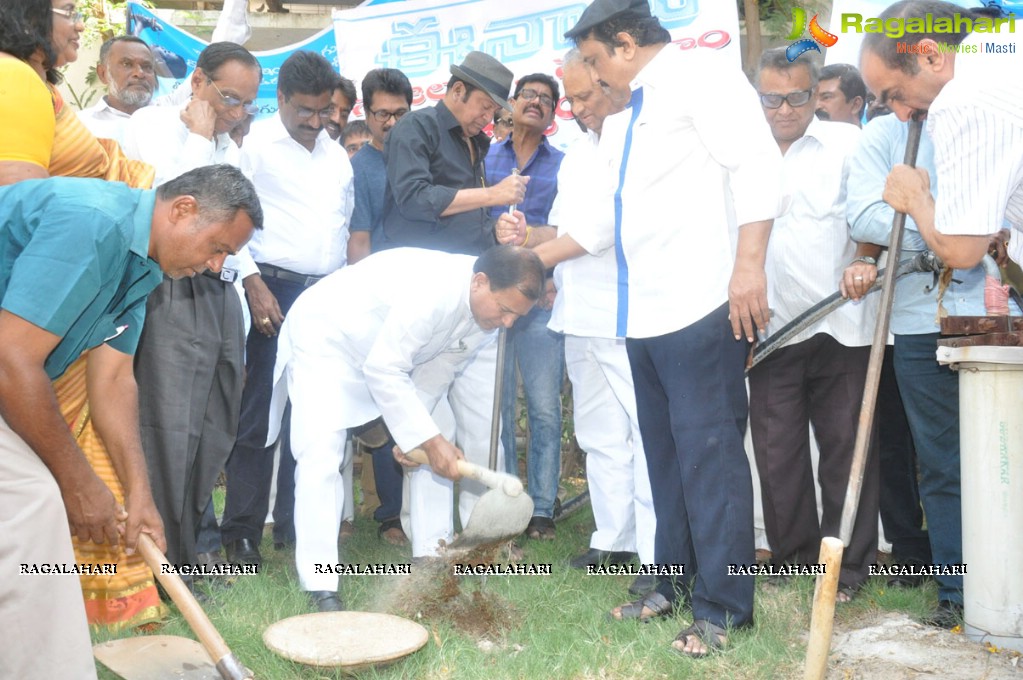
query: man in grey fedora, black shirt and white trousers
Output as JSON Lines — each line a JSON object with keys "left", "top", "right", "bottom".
{"left": 373, "top": 47, "right": 529, "bottom": 557}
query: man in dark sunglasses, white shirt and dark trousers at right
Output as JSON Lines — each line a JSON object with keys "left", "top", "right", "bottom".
{"left": 749, "top": 48, "right": 879, "bottom": 601}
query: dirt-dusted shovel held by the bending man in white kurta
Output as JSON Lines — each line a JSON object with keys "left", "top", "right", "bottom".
{"left": 406, "top": 449, "right": 533, "bottom": 550}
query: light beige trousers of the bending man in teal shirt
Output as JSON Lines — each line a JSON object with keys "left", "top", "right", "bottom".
{"left": 0, "top": 411, "right": 96, "bottom": 680}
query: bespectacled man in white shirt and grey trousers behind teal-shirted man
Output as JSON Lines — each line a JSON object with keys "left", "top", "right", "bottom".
{"left": 124, "top": 42, "right": 263, "bottom": 584}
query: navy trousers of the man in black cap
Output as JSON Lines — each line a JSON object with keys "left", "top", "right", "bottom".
{"left": 626, "top": 305, "right": 754, "bottom": 627}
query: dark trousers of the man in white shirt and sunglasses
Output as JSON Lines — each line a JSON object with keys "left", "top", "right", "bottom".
{"left": 750, "top": 333, "right": 879, "bottom": 588}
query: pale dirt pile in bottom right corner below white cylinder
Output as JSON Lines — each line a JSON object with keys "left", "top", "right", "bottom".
{"left": 827, "top": 613, "right": 1023, "bottom": 680}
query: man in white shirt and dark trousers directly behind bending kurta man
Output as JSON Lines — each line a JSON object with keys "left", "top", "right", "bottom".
{"left": 214, "top": 51, "right": 354, "bottom": 605}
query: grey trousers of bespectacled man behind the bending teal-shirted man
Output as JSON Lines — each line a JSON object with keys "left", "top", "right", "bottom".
{"left": 135, "top": 276, "right": 244, "bottom": 564}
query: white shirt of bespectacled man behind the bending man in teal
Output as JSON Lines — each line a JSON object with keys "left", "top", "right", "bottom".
{"left": 122, "top": 103, "right": 259, "bottom": 278}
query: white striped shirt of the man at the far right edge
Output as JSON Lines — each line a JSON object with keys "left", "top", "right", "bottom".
{"left": 927, "top": 33, "right": 1023, "bottom": 262}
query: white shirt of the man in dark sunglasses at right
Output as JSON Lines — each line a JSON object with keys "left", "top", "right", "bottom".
{"left": 766, "top": 118, "right": 877, "bottom": 347}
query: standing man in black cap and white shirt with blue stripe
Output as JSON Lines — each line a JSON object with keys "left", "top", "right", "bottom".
{"left": 527, "top": 0, "right": 781, "bottom": 656}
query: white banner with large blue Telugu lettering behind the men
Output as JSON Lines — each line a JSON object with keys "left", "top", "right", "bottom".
{"left": 333, "top": 0, "right": 742, "bottom": 148}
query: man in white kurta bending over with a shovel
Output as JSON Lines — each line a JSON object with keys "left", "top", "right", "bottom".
{"left": 269, "top": 245, "right": 543, "bottom": 600}
